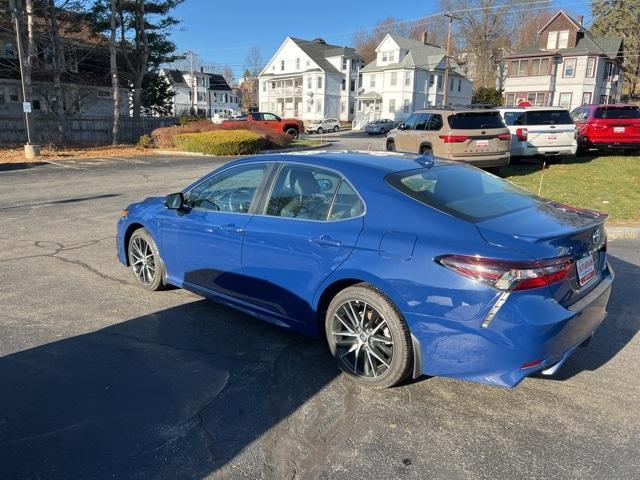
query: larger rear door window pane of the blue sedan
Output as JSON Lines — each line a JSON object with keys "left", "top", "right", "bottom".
{"left": 266, "top": 165, "right": 341, "bottom": 220}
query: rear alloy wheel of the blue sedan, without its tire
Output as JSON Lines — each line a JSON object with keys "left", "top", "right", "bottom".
{"left": 331, "top": 300, "right": 393, "bottom": 378}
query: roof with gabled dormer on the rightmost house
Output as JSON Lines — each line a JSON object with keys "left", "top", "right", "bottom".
{"left": 505, "top": 10, "right": 623, "bottom": 59}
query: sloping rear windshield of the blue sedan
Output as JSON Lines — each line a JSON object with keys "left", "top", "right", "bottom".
{"left": 386, "top": 165, "right": 540, "bottom": 223}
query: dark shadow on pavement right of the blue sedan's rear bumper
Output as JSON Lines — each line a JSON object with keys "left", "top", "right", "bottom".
{"left": 544, "top": 254, "right": 640, "bottom": 380}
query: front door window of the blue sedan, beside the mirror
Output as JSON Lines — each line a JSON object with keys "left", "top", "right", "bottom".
{"left": 185, "top": 164, "right": 267, "bottom": 213}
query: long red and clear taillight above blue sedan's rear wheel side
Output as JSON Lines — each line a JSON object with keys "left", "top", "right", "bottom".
{"left": 436, "top": 255, "right": 573, "bottom": 291}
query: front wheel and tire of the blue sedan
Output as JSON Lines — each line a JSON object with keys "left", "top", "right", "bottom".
{"left": 127, "top": 228, "right": 166, "bottom": 292}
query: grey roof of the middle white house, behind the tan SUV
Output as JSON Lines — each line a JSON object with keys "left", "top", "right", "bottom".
{"left": 361, "top": 34, "right": 464, "bottom": 76}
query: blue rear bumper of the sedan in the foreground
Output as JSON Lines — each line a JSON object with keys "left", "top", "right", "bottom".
{"left": 406, "top": 264, "right": 614, "bottom": 388}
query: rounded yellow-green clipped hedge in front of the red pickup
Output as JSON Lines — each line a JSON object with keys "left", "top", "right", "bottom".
{"left": 173, "top": 130, "right": 263, "bottom": 155}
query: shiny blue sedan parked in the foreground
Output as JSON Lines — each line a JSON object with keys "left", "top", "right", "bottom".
{"left": 117, "top": 152, "right": 614, "bottom": 387}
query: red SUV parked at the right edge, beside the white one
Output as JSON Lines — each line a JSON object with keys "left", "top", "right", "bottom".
{"left": 571, "top": 104, "right": 640, "bottom": 153}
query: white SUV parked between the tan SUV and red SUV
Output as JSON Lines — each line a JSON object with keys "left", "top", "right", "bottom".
{"left": 498, "top": 107, "right": 578, "bottom": 157}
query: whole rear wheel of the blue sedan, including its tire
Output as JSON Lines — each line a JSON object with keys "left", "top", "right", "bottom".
{"left": 325, "top": 283, "right": 413, "bottom": 388}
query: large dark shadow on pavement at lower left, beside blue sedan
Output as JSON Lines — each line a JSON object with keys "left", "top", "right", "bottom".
{"left": 0, "top": 300, "right": 338, "bottom": 479}
